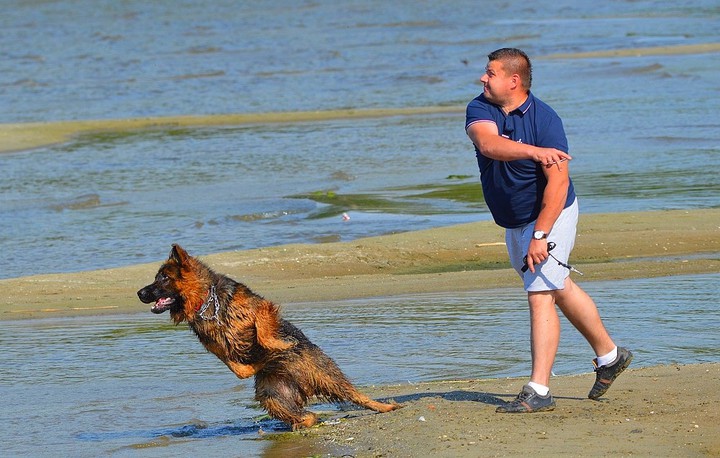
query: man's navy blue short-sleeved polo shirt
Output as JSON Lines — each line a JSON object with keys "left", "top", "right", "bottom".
{"left": 465, "top": 93, "right": 575, "bottom": 228}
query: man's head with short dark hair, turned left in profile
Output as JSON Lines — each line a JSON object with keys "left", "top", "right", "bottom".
{"left": 480, "top": 48, "right": 532, "bottom": 105}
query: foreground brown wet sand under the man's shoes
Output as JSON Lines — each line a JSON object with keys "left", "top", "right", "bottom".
{"left": 292, "top": 363, "right": 720, "bottom": 458}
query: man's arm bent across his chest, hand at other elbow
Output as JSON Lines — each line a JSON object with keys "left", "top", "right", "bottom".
{"left": 467, "top": 121, "right": 572, "bottom": 168}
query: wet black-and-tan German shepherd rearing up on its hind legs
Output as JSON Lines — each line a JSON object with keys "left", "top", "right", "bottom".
{"left": 137, "top": 244, "right": 400, "bottom": 430}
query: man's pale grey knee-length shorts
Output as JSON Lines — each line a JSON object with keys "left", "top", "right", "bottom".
{"left": 505, "top": 199, "right": 578, "bottom": 291}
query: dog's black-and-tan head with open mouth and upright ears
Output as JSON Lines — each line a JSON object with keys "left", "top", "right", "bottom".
{"left": 137, "top": 244, "right": 207, "bottom": 323}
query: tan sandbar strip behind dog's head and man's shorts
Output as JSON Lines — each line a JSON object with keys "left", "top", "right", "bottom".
{"left": 0, "top": 209, "right": 720, "bottom": 320}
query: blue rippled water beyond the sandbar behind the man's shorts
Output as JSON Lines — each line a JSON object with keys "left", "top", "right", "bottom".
{"left": 0, "top": 0, "right": 720, "bottom": 278}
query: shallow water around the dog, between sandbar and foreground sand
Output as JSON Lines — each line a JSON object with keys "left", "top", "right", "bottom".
{"left": 0, "top": 273, "right": 720, "bottom": 456}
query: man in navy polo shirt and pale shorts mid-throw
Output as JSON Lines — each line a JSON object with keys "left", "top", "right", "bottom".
{"left": 465, "top": 48, "right": 632, "bottom": 413}
